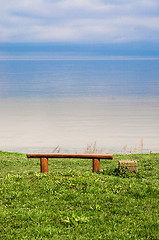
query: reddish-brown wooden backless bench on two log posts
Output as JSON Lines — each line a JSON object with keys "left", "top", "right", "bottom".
{"left": 27, "top": 153, "right": 113, "bottom": 173}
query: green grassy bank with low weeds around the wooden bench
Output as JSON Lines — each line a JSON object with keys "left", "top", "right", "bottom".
{"left": 0, "top": 151, "right": 159, "bottom": 240}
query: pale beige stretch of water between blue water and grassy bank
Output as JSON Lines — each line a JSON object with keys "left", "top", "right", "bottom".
{"left": 0, "top": 98, "right": 159, "bottom": 152}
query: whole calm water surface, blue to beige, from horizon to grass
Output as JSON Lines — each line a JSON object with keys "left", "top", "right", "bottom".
{"left": 0, "top": 60, "right": 159, "bottom": 152}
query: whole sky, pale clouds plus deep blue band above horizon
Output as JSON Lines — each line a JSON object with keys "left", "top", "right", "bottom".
{"left": 0, "top": 0, "right": 159, "bottom": 59}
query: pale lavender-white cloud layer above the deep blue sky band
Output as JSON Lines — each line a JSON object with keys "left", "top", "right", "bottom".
{"left": 0, "top": 0, "right": 159, "bottom": 43}
